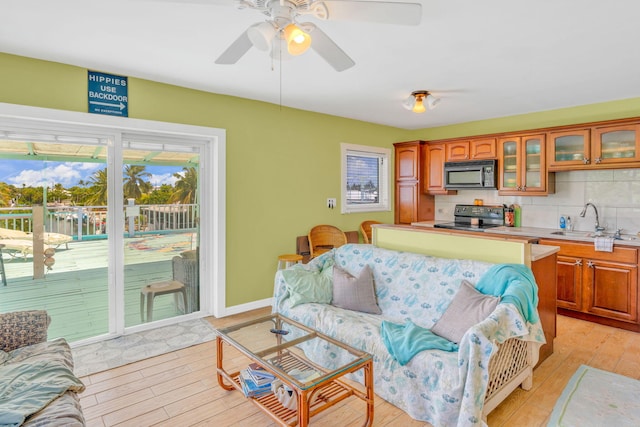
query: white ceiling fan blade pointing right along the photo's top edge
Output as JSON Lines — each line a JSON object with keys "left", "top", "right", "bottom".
{"left": 316, "top": 0, "right": 422, "bottom": 25}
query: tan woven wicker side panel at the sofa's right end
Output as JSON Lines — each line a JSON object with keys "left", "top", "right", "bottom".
{"left": 482, "top": 338, "right": 540, "bottom": 418}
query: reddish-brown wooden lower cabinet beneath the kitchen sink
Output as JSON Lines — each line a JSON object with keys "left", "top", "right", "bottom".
{"left": 540, "top": 239, "right": 640, "bottom": 330}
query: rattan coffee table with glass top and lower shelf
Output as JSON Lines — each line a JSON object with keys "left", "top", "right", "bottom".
{"left": 216, "top": 314, "right": 374, "bottom": 426}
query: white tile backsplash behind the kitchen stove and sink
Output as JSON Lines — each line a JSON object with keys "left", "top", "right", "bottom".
{"left": 435, "top": 169, "right": 640, "bottom": 234}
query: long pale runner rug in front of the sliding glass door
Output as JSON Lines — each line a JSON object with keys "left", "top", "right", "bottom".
{"left": 72, "top": 319, "right": 216, "bottom": 377}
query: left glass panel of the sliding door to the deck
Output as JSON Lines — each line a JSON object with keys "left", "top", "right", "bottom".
{"left": 0, "top": 134, "right": 110, "bottom": 341}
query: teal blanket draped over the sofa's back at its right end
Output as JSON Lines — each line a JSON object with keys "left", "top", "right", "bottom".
{"left": 476, "top": 264, "right": 538, "bottom": 323}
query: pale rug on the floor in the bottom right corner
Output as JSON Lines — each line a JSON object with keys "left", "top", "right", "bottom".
{"left": 548, "top": 365, "right": 640, "bottom": 427}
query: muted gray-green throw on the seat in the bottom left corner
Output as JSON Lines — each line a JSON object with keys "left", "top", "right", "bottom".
{"left": 0, "top": 360, "right": 84, "bottom": 427}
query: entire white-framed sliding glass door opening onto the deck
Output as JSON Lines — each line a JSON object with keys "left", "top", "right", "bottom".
{"left": 0, "top": 104, "right": 224, "bottom": 342}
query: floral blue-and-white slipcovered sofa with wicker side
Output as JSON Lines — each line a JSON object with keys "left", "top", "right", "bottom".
{"left": 273, "top": 244, "right": 545, "bottom": 426}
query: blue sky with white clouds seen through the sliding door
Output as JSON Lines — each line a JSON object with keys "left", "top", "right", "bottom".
{"left": 0, "top": 160, "right": 182, "bottom": 188}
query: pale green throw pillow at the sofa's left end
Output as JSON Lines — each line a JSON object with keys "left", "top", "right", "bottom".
{"left": 282, "top": 263, "right": 333, "bottom": 307}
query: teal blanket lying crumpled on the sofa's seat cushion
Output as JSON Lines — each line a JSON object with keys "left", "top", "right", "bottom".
{"left": 380, "top": 320, "right": 458, "bottom": 366}
